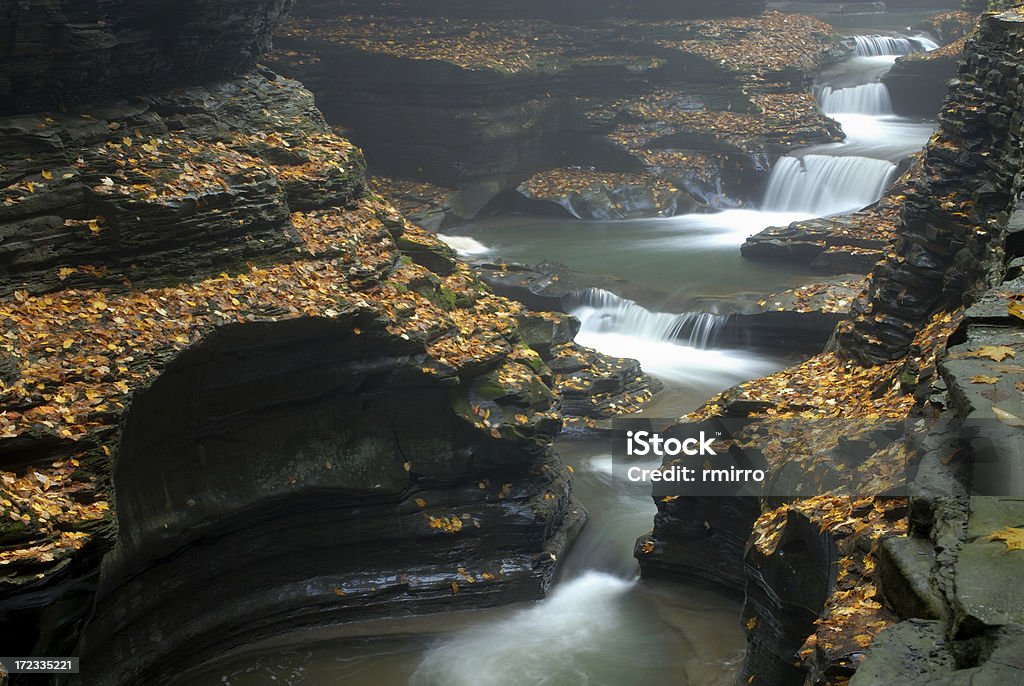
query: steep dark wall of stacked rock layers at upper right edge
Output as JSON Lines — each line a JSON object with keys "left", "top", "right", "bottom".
{"left": 838, "top": 13, "right": 1024, "bottom": 365}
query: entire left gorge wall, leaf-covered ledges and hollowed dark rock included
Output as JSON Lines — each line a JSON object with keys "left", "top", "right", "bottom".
{"left": 0, "top": 0, "right": 688, "bottom": 684}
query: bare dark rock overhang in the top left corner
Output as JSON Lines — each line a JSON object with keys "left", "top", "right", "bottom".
{"left": 0, "top": 0, "right": 292, "bottom": 114}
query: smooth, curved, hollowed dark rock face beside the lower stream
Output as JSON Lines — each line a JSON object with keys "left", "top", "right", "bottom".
{"left": 83, "top": 317, "right": 585, "bottom": 684}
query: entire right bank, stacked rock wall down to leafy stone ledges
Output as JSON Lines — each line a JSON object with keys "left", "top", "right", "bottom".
{"left": 637, "top": 11, "right": 1024, "bottom": 685}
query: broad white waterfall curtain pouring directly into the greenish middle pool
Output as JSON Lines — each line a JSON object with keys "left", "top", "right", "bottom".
{"left": 764, "top": 155, "right": 896, "bottom": 216}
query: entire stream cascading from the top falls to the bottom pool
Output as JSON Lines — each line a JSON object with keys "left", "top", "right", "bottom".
{"left": 189, "top": 14, "right": 937, "bottom": 686}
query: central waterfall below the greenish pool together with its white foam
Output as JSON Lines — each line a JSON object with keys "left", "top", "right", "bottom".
{"left": 570, "top": 289, "right": 777, "bottom": 385}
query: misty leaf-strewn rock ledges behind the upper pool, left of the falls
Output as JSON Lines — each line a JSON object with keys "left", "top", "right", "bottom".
{"left": 271, "top": 7, "right": 842, "bottom": 222}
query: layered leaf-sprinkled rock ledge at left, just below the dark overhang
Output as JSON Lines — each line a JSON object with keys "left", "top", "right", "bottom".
{"left": 0, "top": 73, "right": 365, "bottom": 294}
